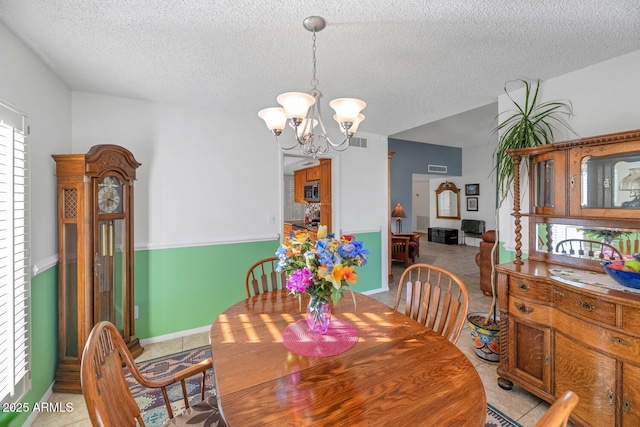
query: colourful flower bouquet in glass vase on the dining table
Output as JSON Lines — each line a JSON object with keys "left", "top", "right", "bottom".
{"left": 276, "top": 226, "right": 369, "bottom": 333}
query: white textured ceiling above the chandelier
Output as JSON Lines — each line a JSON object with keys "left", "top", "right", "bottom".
{"left": 0, "top": 0, "right": 640, "bottom": 145}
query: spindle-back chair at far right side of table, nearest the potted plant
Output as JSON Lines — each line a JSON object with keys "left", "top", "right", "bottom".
{"left": 393, "top": 264, "right": 469, "bottom": 344}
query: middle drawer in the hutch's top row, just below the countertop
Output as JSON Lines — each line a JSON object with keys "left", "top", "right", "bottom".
{"left": 553, "top": 287, "right": 616, "bottom": 326}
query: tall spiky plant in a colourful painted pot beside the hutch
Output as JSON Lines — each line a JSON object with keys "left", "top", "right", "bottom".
{"left": 467, "top": 80, "right": 575, "bottom": 361}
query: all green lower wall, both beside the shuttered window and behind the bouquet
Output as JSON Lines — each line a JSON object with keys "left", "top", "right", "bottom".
{"left": 15, "top": 232, "right": 382, "bottom": 427}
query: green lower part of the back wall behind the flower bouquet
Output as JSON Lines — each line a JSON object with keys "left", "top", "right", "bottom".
{"left": 135, "top": 232, "right": 381, "bottom": 339}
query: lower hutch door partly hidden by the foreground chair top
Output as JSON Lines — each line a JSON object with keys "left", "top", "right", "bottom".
{"left": 554, "top": 333, "right": 616, "bottom": 427}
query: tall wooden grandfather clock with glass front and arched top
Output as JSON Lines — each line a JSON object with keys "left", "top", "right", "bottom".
{"left": 52, "top": 145, "right": 143, "bottom": 393}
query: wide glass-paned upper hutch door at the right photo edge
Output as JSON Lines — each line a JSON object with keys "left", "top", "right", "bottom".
{"left": 569, "top": 141, "right": 640, "bottom": 218}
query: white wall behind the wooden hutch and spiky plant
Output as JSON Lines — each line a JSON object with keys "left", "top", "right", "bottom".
{"left": 498, "top": 50, "right": 640, "bottom": 251}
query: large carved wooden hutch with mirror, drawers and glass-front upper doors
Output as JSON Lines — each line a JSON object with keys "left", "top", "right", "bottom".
{"left": 496, "top": 130, "right": 640, "bottom": 426}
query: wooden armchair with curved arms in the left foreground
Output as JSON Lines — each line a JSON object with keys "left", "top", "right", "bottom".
{"left": 80, "top": 321, "right": 224, "bottom": 427}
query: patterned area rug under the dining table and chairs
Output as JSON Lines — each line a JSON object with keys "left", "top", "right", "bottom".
{"left": 125, "top": 346, "right": 522, "bottom": 427}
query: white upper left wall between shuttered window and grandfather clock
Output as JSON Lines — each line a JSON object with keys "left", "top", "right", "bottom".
{"left": 0, "top": 23, "right": 71, "bottom": 269}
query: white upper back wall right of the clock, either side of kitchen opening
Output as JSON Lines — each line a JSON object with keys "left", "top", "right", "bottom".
{"left": 73, "top": 92, "right": 387, "bottom": 264}
